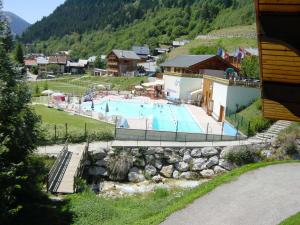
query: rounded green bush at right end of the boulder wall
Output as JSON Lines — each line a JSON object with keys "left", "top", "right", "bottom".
{"left": 225, "top": 146, "right": 259, "bottom": 166}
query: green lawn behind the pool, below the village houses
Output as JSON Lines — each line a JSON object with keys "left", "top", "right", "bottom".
{"left": 29, "top": 76, "right": 147, "bottom": 95}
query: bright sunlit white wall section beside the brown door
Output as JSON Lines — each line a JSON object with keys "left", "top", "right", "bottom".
{"left": 212, "top": 82, "right": 228, "bottom": 119}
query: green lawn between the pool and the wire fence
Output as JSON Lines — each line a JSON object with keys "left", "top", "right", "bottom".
{"left": 34, "top": 105, "right": 114, "bottom": 143}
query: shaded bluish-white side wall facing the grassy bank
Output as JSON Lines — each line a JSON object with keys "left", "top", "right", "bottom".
{"left": 227, "top": 86, "right": 261, "bottom": 114}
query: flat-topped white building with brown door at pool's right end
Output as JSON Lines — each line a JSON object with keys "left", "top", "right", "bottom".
{"left": 202, "top": 70, "right": 260, "bottom": 122}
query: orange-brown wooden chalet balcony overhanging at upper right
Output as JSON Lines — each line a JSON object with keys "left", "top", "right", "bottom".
{"left": 255, "top": 0, "right": 300, "bottom": 121}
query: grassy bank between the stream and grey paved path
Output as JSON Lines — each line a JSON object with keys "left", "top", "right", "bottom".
{"left": 63, "top": 161, "right": 298, "bottom": 225}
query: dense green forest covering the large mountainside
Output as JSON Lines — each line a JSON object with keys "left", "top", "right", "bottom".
{"left": 22, "top": 0, "right": 254, "bottom": 59}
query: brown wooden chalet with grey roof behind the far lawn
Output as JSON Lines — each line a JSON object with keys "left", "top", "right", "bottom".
{"left": 107, "top": 50, "right": 141, "bottom": 76}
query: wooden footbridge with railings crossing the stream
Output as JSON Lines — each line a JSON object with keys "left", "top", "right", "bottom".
{"left": 47, "top": 142, "right": 89, "bottom": 194}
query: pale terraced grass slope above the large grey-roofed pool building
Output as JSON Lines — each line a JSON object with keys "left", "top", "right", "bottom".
{"left": 168, "top": 25, "right": 257, "bottom": 59}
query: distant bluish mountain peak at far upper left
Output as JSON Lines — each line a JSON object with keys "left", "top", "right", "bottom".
{"left": 4, "top": 12, "right": 30, "bottom": 36}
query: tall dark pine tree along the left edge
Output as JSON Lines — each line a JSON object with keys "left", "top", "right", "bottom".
{"left": 0, "top": 0, "right": 47, "bottom": 224}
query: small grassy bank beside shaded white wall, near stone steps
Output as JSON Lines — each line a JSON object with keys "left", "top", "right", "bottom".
{"left": 226, "top": 99, "right": 272, "bottom": 136}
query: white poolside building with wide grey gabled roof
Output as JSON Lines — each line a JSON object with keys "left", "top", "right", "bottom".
{"left": 160, "top": 55, "right": 238, "bottom": 102}
